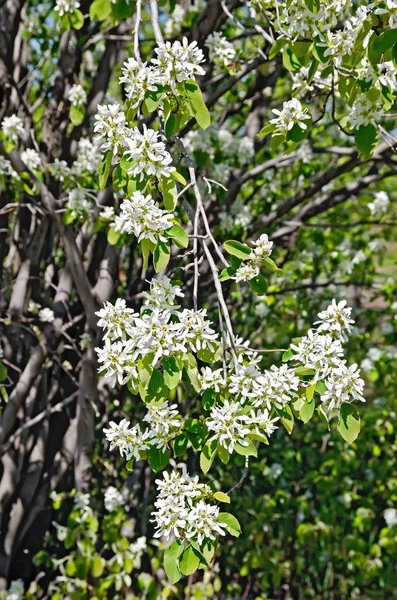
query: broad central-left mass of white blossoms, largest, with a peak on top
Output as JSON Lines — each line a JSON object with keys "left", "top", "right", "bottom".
{"left": 97, "top": 276, "right": 218, "bottom": 385}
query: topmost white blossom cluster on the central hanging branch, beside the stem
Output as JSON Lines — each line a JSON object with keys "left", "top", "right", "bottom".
{"left": 151, "top": 37, "right": 205, "bottom": 94}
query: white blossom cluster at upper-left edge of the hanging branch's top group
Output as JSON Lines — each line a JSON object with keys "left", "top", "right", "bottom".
{"left": 94, "top": 104, "right": 127, "bottom": 156}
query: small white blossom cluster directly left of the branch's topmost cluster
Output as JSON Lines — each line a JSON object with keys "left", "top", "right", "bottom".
{"left": 119, "top": 58, "right": 161, "bottom": 108}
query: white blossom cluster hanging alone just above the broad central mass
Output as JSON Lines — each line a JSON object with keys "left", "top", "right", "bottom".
{"left": 114, "top": 191, "right": 174, "bottom": 244}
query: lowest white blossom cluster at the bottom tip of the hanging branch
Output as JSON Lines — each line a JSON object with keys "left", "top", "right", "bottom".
{"left": 152, "top": 471, "right": 225, "bottom": 544}
